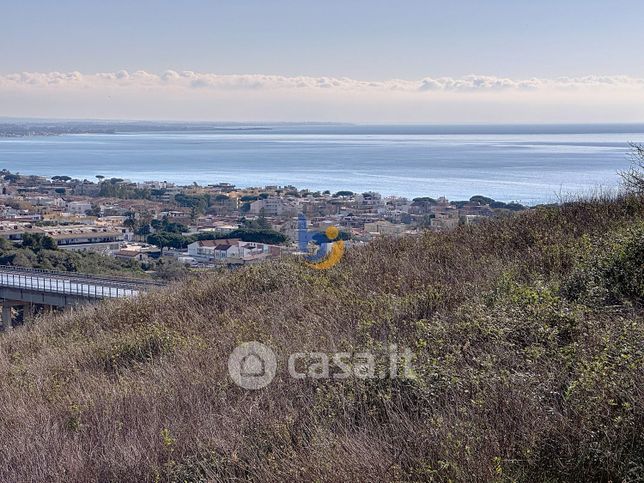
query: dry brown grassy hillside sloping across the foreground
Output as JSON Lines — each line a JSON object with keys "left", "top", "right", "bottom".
{"left": 0, "top": 196, "right": 644, "bottom": 481}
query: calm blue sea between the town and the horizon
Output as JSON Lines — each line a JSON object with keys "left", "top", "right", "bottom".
{"left": 0, "top": 124, "right": 644, "bottom": 204}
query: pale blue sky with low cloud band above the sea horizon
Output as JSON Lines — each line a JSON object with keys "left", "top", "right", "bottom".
{"left": 0, "top": 0, "right": 644, "bottom": 123}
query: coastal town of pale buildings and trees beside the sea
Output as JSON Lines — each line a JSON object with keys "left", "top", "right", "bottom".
{"left": 0, "top": 170, "right": 526, "bottom": 271}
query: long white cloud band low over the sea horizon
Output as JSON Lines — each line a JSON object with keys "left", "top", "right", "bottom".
{"left": 0, "top": 70, "right": 644, "bottom": 122}
